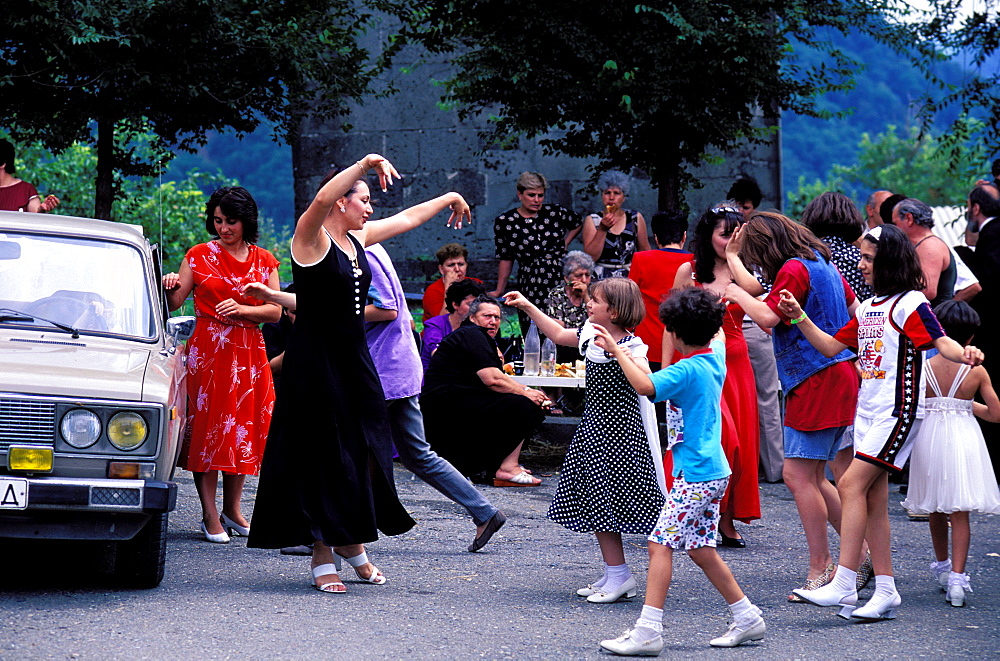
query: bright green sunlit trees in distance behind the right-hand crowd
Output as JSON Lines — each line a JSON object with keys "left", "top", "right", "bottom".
{"left": 786, "top": 119, "right": 989, "bottom": 218}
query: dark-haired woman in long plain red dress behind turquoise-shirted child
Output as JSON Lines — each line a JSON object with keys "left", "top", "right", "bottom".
{"left": 663, "top": 202, "right": 760, "bottom": 548}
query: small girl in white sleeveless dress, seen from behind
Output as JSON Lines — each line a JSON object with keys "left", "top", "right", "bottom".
{"left": 903, "top": 300, "right": 1000, "bottom": 606}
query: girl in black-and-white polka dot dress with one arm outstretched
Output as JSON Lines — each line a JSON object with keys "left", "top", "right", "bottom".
{"left": 504, "top": 278, "right": 665, "bottom": 603}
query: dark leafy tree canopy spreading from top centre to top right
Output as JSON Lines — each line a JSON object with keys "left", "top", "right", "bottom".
{"left": 394, "top": 0, "right": 1000, "bottom": 208}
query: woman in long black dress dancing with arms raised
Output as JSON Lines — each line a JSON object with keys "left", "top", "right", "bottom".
{"left": 249, "top": 154, "right": 471, "bottom": 593}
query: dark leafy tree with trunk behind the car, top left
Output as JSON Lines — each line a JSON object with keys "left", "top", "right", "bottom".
{"left": 0, "top": 0, "right": 386, "bottom": 218}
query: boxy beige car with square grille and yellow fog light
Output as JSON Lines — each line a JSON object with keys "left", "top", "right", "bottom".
{"left": 0, "top": 211, "right": 193, "bottom": 587}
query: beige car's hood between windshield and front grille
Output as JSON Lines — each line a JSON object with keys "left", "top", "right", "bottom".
{"left": 0, "top": 333, "right": 151, "bottom": 401}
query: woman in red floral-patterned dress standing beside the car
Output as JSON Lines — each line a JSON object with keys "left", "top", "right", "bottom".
{"left": 163, "top": 187, "right": 281, "bottom": 544}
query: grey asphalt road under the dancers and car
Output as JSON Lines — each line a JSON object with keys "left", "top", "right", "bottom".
{"left": 0, "top": 468, "right": 1000, "bottom": 660}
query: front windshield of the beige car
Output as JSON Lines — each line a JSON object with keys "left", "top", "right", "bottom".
{"left": 0, "top": 232, "right": 155, "bottom": 338}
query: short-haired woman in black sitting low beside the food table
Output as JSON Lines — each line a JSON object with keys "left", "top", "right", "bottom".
{"left": 420, "top": 294, "right": 549, "bottom": 487}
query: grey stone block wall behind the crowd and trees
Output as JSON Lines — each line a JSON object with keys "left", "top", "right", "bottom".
{"left": 292, "top": 38, "right": 783, "bottom": 292}
